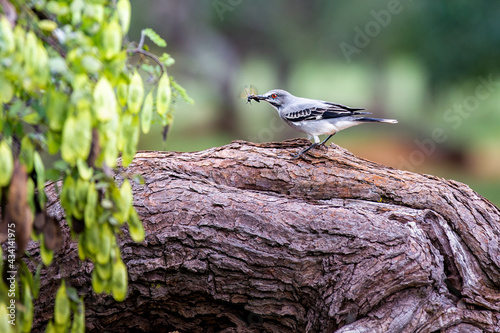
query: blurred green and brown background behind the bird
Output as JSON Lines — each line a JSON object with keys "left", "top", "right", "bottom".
{"left": 129, "top": 0, "right": 500, "bottom": 206}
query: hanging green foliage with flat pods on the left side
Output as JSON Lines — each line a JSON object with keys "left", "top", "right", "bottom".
{"left": 0, "top": 0, "right": 192, "bottom": 332}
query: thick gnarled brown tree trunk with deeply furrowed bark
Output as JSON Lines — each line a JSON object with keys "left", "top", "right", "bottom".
{"left": 31, "top": 140, "right": 500, "bottom": 333}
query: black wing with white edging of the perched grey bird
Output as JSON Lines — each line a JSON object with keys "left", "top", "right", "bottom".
{"left": 284, "top": 102, "right": 370, "bottom": 122}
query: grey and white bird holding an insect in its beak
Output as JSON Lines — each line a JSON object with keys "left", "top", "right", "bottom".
{"left": 247, "top": 89, "right": 398, "bottom": 158}
